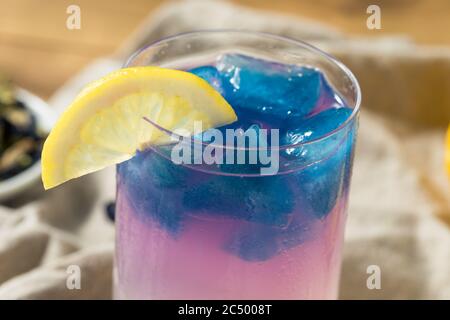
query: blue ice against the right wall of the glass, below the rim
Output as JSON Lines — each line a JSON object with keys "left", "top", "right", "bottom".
{"left": 281, "top": 107, "right": 354, "bottom": 218}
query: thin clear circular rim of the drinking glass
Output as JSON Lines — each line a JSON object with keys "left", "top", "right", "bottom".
{"left": 123, "top": 29, "right": 361, "bottom": 150}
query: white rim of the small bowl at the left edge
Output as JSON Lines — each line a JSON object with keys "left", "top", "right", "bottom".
{"left": 0, "top": 88, "right": 56, "bottom": 201}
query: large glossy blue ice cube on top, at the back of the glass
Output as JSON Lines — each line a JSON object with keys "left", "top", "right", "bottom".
{"left": 216, "top": 54, "right": 323, "bottom": 119}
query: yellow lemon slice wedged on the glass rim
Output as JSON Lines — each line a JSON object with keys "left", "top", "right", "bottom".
{"left": 42, "top": 67, "right": 237, "bottom": 189}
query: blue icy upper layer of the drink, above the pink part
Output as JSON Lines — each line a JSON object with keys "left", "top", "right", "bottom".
{"left": 118, "top": 54, "right": 355, "bottom": 261}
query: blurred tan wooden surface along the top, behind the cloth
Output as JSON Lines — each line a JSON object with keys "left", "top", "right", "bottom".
{"left": 0, "top": 0, "right": 450, "bottom": 98}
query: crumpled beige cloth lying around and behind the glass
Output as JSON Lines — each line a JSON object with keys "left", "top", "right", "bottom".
{"left": 0, "top": 1, "right": 450, "bottom": 299}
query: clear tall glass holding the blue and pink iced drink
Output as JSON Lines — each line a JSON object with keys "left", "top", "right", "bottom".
{"left": 114, "top": 30, "right": 360, "bottom": 299}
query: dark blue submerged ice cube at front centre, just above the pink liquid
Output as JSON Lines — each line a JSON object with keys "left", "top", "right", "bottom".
{"left": 183, "top": 176, "right": 294, "bottom": 226}
